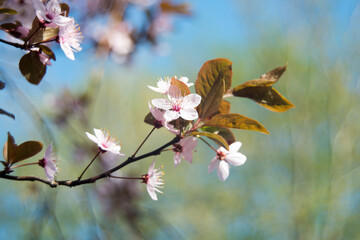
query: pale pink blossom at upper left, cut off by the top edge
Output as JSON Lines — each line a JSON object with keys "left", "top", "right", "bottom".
{"left": 33, "top": 0, "right": 71, "bottom": 27}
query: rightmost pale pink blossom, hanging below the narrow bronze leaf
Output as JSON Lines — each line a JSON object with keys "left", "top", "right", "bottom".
{"left": 208, "top": 142, "right": 246, "bottom": 181}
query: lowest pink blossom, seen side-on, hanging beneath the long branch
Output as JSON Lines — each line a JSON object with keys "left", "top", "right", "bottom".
{"left": 142, "top": 159, "right": 164, "bottom": 201}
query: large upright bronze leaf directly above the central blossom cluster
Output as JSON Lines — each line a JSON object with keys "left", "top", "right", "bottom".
{"left": 195, "top": 58, "right": 232, "bottom": 118}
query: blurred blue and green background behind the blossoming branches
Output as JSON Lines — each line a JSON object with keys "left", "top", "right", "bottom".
{"left": 0, "top": 0, "right": 360, "bottom": 239}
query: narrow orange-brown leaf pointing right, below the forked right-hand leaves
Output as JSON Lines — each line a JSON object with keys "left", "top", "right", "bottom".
{"left": 204, "top": 113, "right": 270, "bottom": 134}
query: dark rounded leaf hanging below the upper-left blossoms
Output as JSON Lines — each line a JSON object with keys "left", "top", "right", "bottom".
{"left": 19, "top": 51, "right": 46, "bottom": 85}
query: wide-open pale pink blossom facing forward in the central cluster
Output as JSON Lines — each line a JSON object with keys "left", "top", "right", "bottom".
{"left": 151, "top": 85, "right": 201, "bottom": 122}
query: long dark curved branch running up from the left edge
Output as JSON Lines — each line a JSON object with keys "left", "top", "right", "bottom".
{"left": 0, "top": 136, "right": 180, "bottom": 187}
